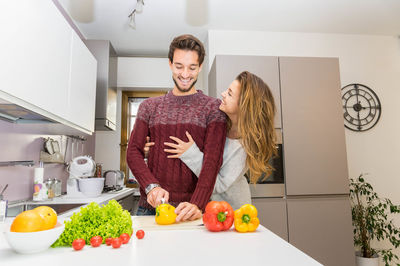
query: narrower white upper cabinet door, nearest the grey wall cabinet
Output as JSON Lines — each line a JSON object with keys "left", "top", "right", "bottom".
{"left": 67, "top": 33, "right": 97, "bottom": 132}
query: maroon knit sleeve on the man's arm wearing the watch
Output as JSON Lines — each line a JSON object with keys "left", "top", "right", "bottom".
{"left": 126, "top": 101, "right": 159, "bottom": 188}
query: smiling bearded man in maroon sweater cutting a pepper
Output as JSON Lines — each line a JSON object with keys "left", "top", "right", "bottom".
{"left": 127, "top": 35, "right": 226, "bottom": 222}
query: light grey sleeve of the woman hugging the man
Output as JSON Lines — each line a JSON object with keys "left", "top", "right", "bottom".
{"left": 179, "top": 143, "right": 246, "bottom": 193}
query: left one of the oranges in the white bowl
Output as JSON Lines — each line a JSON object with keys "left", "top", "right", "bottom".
{"left": 10, "top": 210, "right": 43, "bottom": 232}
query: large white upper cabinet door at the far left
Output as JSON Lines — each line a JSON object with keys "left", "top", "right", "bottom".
{"left": 0, "top": 0, "right": 72, "bottom": 117}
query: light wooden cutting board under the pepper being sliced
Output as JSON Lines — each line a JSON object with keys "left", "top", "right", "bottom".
{"left": 132, "top": 216, "right": 204, "bottom": 231}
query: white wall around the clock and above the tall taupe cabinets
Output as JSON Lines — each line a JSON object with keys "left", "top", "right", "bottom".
{"left": 208, "top": 28, "right": 400, "bottom": 260}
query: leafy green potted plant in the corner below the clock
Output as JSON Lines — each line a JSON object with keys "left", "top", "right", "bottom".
{"left": 350, "top": 174, "right": 400, "bottom": 266}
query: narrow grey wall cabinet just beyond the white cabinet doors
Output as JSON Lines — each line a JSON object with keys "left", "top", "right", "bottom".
{"left": 84, "top": 40, "right": 118, "bottom": 131}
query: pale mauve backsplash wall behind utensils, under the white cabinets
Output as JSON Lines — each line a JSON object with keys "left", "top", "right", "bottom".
{"left": 0, "top": 120, "right": 95, "bottom": 201}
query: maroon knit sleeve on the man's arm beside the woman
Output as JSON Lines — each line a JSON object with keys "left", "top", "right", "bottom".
{"left": 190, "top": 106, "right": 226, "bottom": 211}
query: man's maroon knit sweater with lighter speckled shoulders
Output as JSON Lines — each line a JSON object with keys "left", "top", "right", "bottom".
{"left": 127, "top": 91, "right": 226, "bottom": 211}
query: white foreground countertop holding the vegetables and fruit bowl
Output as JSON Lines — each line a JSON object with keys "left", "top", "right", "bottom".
{"left": 0, "top": 217, "right": 321, "bottom": 266}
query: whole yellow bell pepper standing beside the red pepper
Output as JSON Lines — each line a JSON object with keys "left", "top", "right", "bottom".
{"left": 234, "top": 204, "right": 260, "bottom": 233}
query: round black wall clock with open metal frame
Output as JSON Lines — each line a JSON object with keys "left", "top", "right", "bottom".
{"left": 342, "top": 83, "right": 382, "bottom": 132}
